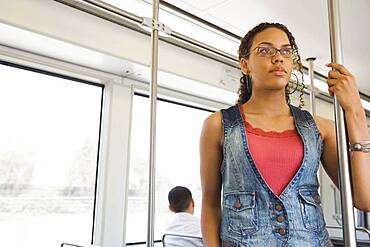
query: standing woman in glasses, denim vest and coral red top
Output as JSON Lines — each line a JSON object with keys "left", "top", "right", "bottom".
{"left": 200, "top": 23, "right": 370, "bottom": 247}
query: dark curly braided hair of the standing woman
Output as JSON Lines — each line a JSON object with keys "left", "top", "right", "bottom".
{"left": 237, "top": 22, "right": 305, "bottom": 108}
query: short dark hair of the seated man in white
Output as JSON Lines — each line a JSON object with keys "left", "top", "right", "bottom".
{"left": 168, "top": 186, "right": 192, "bottom": 213}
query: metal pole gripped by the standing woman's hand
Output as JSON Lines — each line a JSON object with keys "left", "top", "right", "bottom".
{"left": 328, "top": 0, "right": 356, "bottom": 247}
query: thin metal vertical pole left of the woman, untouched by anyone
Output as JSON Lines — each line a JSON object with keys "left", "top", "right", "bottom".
{"left": 146, "top": 0, "right": 159, "bottom": 247}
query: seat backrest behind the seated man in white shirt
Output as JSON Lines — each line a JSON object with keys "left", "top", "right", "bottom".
{"left": 162, "top": 233, "right": 204, "bottom": 247}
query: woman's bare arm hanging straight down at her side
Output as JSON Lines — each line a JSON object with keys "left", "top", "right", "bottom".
{"left": 200, "top": 112, "right": 223, "bottom": 247}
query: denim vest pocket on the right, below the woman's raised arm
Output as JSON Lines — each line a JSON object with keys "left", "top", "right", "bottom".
{"left": 298, "top": 189, "right": 325, "bottom": 232}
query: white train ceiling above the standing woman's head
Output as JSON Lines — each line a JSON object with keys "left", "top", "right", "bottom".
{"left": 165, "top": 0, "right": 370, "bottom": 95}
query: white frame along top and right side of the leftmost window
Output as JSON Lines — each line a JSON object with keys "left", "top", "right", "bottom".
{"left": 0, "top": 45, "right": 133, "bottom": 246}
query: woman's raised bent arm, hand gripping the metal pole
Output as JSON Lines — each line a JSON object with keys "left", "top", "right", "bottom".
{"left": 316, "top": 64, "right": 370, "bottom": 211}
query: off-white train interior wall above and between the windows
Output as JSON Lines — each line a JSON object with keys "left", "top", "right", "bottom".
{"left": 0, "top": 0, "right": 370, "bottom": 247}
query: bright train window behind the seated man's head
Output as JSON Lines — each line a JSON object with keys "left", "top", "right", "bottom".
{"left": 126, "top": 95, "right": 211, "bottom": 243}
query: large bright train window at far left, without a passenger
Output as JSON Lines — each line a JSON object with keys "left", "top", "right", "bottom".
{"left": 0, "top": 64, "right": 103, "bottom": 247}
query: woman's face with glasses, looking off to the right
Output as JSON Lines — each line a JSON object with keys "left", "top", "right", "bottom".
{"left": 240, "top": 28, "right": 293, "bottom": 90}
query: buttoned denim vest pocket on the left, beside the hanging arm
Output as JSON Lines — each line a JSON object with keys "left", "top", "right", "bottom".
{"left": 223, "top": 192, "right": 257, "bottom": 235}
